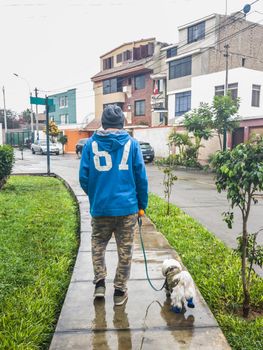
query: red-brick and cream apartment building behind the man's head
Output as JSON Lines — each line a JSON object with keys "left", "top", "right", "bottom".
{"left": 91, "top": 38, "right": 167, "bottom": 127}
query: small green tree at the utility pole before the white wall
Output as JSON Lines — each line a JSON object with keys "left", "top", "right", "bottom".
{"left": 212, "top": 92, "right": 239, "bottom": 150}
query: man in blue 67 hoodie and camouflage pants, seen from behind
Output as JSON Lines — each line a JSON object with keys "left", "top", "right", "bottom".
{"left": 79, "top": 105, "right": 148, "bottom": 305}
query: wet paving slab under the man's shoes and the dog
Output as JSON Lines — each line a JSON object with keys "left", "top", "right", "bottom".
{"left": 53, "top": 280, "right": 218, "bottom": 332}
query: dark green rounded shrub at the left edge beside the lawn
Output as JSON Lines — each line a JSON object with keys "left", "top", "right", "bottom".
{"left": 0, "top": 145, "right": 15, "bottom": 190}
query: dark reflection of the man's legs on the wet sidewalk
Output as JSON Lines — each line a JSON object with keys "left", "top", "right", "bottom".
{"left": 92, "top": 298, "right": 132, "bottom": 350}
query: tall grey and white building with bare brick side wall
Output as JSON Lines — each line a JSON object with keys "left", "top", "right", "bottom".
{"left": 165, "top": 12, "right": 263, "bottom": 143}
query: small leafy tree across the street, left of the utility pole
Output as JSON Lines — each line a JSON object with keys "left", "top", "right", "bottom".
{"left": 184, "top": 103, "right": 213, "bottom": 160}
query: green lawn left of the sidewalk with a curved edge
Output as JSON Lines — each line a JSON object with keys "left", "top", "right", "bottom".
{"left": 0, "top": 176, "right": 78, "bottom": 350}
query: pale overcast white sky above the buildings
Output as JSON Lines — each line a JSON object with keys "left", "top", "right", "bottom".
{"left": 0, "top": 0, "right": 263, "bottom": 119}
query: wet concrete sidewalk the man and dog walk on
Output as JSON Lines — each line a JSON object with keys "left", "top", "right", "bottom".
{"left": 50, "top": 178, "right": 230, "bottom": 350}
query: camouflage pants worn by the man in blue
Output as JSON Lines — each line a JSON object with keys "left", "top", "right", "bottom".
{"left": 91, "top": 214, "right": 137, "bottom": 291}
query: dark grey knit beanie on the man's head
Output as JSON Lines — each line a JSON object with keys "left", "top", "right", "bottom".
{"left": 101, "top": 105, "right": 124, "bottom": 129}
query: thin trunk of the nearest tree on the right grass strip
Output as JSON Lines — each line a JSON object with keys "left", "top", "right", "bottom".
{"left": 242, "top": 215, "right": 250, "bottom": 318}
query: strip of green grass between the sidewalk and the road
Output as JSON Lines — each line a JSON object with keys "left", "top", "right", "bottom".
{"left": 147, "top": 195, "right": 263, "bottom": 350}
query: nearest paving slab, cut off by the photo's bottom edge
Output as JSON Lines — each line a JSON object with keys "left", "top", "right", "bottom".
{"left": 49, "top": 328, "right": 230, "bottom": 350}
